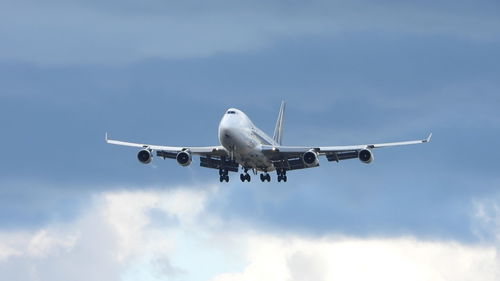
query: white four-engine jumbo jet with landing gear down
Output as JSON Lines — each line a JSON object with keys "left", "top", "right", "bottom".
{"left": 105, "top": 101, "right": 432, "bottom": 182}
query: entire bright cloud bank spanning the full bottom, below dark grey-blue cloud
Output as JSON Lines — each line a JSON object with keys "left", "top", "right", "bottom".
{"left": 0, "top": 186, "right": 500, "bottom": 281}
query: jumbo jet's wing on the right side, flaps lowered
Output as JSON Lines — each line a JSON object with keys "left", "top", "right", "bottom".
{"left": 262, "top": 133, "right": 432, "bottom": 170}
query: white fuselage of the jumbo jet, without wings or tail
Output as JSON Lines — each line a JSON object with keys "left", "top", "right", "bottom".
{"left": 219, "top": 108, "right": 278, "bottom": 172}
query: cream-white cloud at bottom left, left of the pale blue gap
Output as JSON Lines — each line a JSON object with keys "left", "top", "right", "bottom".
{"left": 0, "top": 185, "right": 213, "bottom": 280}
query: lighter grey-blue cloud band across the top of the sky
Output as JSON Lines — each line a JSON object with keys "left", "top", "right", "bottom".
{"left": 0, "top": 0, "right": 500, "bottom": 64}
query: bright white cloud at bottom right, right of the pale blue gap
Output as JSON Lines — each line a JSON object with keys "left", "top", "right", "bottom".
{"left": 213, "top": 236, "right": 500, "bottom": 281}
